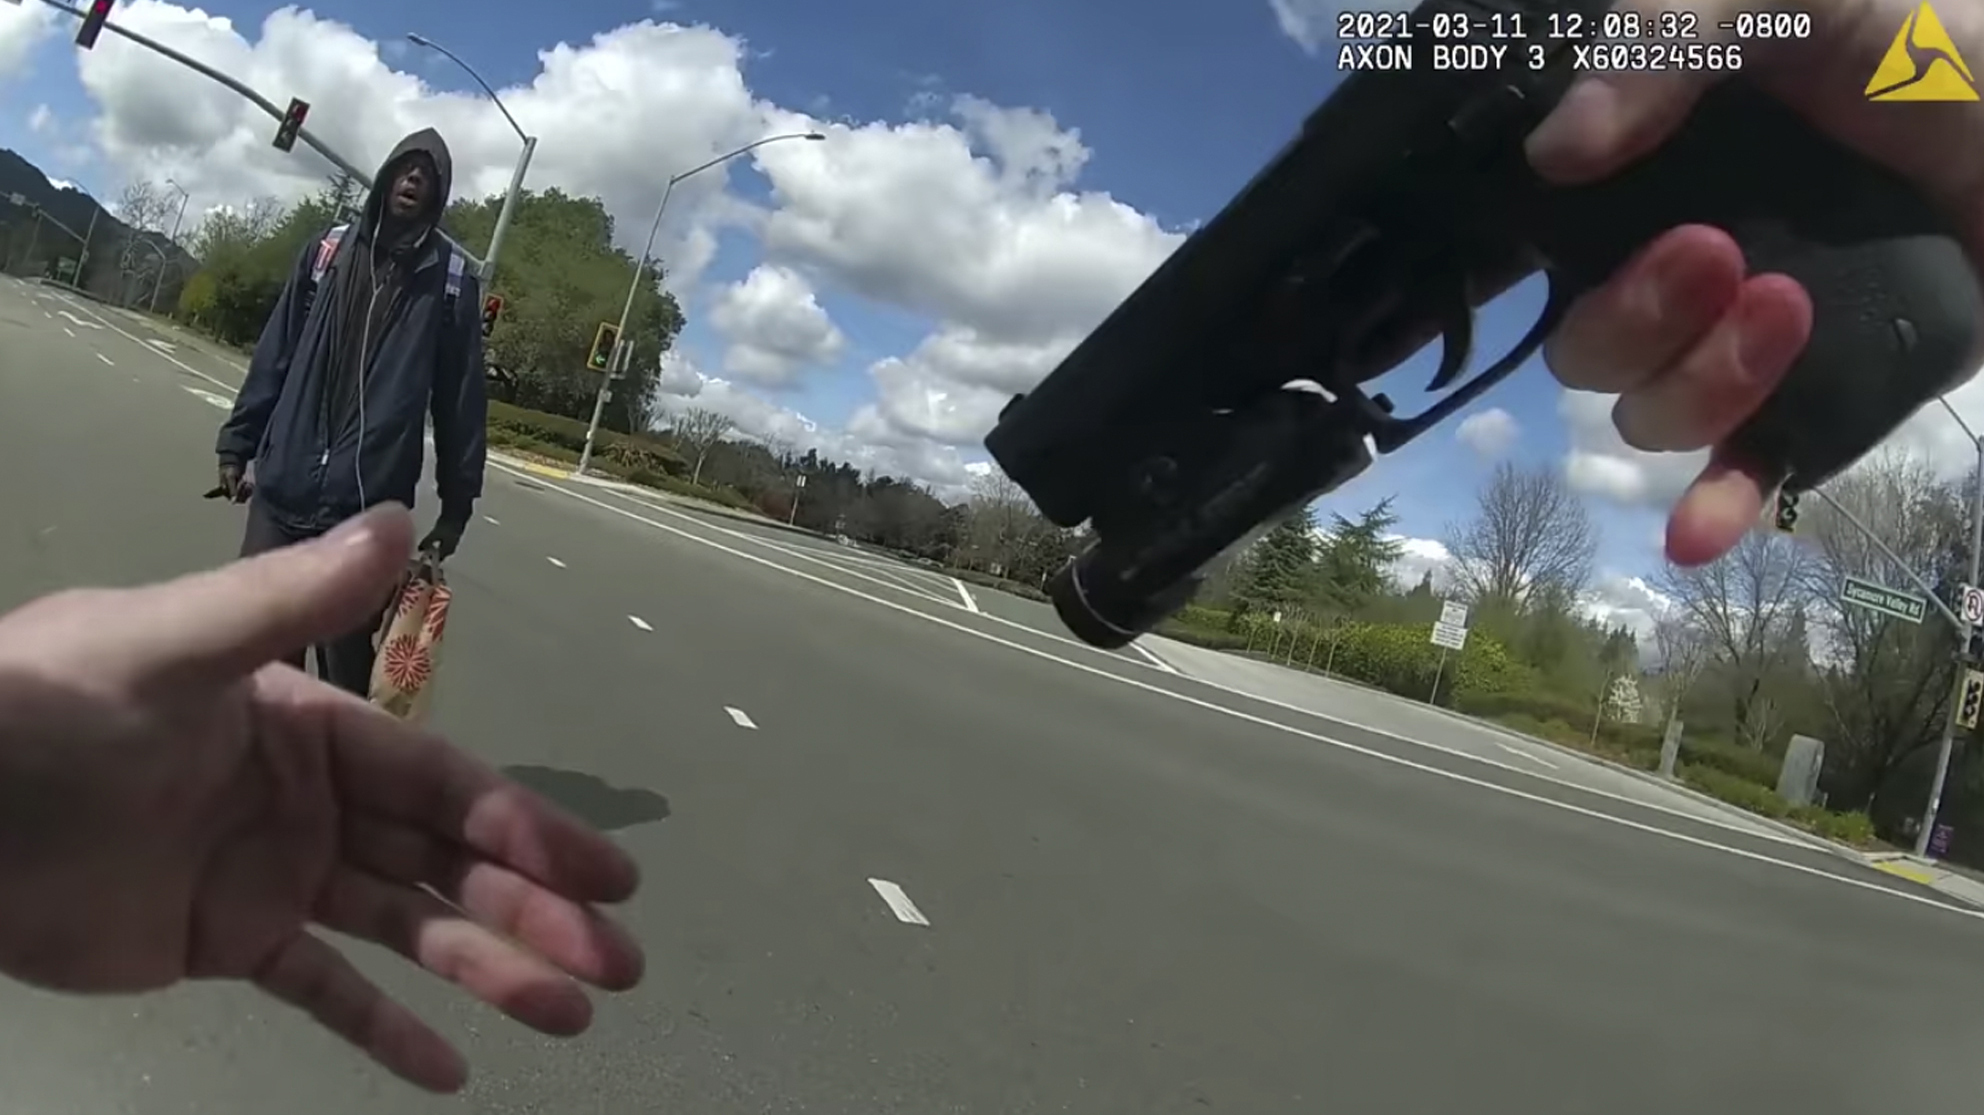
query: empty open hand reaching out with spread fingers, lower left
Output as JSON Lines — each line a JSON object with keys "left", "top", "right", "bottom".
{"left": 0, "top": 506, "right": 643, "bottom": 1091}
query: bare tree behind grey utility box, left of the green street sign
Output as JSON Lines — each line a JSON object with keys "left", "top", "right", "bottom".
{"left": 1657, "top": 530, "right": 1811, "bottom": 748}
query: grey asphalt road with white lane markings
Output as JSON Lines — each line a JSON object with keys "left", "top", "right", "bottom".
{"left": 0, "top": 271, "right": 1984, "bottom": 1115}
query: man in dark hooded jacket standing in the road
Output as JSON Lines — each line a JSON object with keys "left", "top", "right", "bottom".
{"left": 214, "top": 129, "right": 488, "bottom": 696}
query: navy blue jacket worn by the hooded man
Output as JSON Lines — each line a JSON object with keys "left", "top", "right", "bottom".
{"left": 214, "top": 129, "right": 488, "bottom": 532}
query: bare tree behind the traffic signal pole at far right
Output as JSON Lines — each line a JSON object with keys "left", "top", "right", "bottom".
{"left": 1799, "top": 452, "right": 1968, "bottom": 807}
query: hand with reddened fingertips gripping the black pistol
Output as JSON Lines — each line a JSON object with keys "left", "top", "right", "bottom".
{"left": 1530, "top": 0, "right": 1984, "bottom": 565}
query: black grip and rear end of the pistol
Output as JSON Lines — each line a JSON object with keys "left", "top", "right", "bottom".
{"left": 1532, "top": 81, "right": 1984, "bottom": 490}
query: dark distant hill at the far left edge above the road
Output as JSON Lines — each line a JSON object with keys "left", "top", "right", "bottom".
{"left": 0, "top": 147, "right": 198, "bottom": 310}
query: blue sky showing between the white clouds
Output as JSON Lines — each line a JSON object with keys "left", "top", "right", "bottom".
{"left": 0, "top": 0, "right": 1659, "bottom": 591}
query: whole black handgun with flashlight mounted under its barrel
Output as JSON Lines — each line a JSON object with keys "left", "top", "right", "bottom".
{"left": 986, "top": 0, "right": 1984, "bottom": 647}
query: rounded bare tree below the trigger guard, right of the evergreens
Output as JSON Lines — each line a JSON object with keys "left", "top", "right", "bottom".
{"left": 1446, "top": 462, "right": 1597, "bottom": 603}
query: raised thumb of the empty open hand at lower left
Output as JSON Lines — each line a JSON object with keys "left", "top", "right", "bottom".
{"left": 123, "top": 504, "right": 413, "bottom": 684}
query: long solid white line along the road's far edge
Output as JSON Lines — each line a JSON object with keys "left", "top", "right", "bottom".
{"left": 490, "top": 460, "right": 1984, "bottom": 921}
